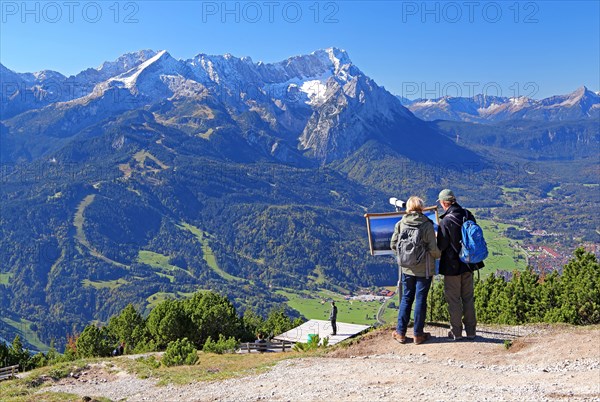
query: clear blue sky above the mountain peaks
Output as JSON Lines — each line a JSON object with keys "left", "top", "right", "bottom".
{"left": 0, "top": 0, "right": 600, "bottom": 99}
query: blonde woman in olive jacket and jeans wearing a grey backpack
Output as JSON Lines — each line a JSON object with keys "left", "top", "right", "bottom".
{"left": 390, "top": 197, "right": 440, "bottom": 345}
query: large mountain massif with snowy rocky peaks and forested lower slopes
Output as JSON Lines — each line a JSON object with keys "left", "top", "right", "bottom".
{"left": 0, "top": 48, "right": 600, "bottom": 350}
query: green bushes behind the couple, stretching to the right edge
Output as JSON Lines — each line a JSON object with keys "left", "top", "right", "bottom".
{"left": 428, "top": 248, "right": 600, "bottom": 325}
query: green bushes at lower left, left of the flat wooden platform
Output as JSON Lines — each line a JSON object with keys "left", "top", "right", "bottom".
{"left": 0, "top": 291, "right": 303, "bottom": 370}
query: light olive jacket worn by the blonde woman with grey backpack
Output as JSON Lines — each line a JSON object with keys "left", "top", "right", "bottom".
{"left": 390, "top": 212, "right": 440, "bottom": 277}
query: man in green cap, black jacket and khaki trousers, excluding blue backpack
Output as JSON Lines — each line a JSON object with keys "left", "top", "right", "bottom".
{"left": 437, "top": 189, "right": 484, "bottom": 340}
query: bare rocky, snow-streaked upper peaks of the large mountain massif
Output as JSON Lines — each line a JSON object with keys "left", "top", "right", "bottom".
{"left": 0, "top": 48, "right": 473, "bottom": 165}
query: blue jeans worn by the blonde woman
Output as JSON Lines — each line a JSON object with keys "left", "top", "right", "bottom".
{"left": 396, "top": 273, "right": 431, "bottom": 336}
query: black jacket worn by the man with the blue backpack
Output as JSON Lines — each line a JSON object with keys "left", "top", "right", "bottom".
{"left": 437, "top": 202, "right": 484, "bottom": 276}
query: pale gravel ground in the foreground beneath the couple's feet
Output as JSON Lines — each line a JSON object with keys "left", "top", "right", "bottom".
{"left": 43, "top": 327, "right": 600, "bottom": 401}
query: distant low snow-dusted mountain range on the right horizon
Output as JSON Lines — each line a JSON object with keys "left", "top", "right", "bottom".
{"left": 398, "top": 86, "right": 600, "bottom": 123}
